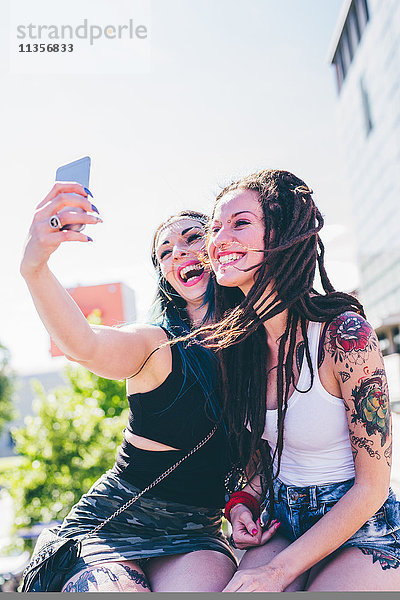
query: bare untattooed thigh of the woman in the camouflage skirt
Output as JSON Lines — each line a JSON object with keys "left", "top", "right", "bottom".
{"left": 146, "top": 550, "right": 236, "bottom": 592}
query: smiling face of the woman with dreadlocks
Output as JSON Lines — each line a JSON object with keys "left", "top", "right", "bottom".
{"left": 207, "top": 189, "right": 265, "bottom": 294}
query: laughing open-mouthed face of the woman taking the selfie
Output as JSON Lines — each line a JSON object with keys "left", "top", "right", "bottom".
{"left": 156, "top": 217, "right": 209, "bottom": 303}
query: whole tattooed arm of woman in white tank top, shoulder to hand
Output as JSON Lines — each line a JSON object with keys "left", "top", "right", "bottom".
{"left": 225, "top": 313, "right": 391, "bottom": 591}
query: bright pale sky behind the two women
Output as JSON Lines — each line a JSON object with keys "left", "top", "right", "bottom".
{"left": 0, "top": 0, "right": 358, "bottom": 374}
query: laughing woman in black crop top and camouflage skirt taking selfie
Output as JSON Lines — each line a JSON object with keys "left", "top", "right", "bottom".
{"left": 21, "top": 183, "right": 278, "bottom": 592}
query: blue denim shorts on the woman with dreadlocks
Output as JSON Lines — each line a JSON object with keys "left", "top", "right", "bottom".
{"left": 261, "top": 479, "right": 400, "bottom": 569}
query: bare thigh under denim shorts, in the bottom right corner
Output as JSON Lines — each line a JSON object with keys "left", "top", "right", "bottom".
{"left": 307, "top": 548, "right": 400, "bottom": 592}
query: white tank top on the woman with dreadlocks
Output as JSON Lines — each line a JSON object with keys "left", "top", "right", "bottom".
{"left": 262, "top": 321, "right": 354, "bottom": 486}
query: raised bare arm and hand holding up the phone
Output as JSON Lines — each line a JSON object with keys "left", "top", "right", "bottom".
{"left": 20, "top": 183, "right": 165, "bottom": 379}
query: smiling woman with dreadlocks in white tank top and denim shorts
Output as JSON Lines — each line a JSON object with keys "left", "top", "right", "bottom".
{"left": 198, "top": 170, "right": 400, "bottom": 592}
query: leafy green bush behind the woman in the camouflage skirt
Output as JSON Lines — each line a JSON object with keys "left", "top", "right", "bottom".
{"left": 3, "top": 366, "right": 127, "bottom": 527}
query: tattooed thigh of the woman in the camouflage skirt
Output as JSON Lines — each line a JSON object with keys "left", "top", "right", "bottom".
{"left": 61, "top": 561, "right": 151, "bottom": 592}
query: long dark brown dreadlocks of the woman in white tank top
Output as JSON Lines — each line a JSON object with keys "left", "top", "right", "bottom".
{"left": 191, "top": 169, "right": 364, "bottom": 514}
